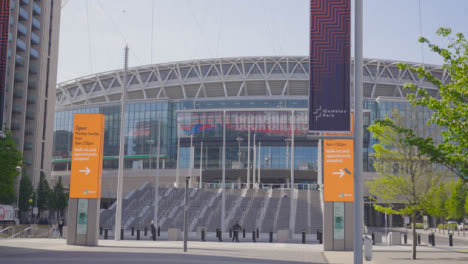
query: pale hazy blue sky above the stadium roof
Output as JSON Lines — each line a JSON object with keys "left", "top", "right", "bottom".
{"left": 57, "top": 0, "right": 468, "bottom": 83}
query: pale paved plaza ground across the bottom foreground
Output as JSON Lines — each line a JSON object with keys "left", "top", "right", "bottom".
{"left": 0, "top": 239, "right": 468, "bottom": 264}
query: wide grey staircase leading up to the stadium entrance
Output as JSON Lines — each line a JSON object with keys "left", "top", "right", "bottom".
{"left": 100, "top": 182, "right": 322, "bottom": 233}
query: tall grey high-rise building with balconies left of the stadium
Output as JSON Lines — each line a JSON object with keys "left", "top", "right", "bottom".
{"left": 0, "top": 0, "right": 61, "bottom": 184}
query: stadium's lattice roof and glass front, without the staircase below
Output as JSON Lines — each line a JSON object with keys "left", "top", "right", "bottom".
{"left": 51, "top": 56, "right": 447, "bottom": 206}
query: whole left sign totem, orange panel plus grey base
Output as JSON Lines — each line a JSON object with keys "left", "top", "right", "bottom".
{"left": 67, "top": 114, "right": 104, "bottom": 246}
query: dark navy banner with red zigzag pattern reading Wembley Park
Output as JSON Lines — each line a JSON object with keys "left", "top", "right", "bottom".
{"left": 309, "top": 0, "right": 351, "bottom": 133}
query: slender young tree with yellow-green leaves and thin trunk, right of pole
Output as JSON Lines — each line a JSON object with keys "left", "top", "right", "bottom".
{"left": 366, "top": 111, "right": 443, "bottom": 259}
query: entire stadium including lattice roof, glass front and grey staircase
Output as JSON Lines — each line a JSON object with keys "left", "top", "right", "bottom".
{"left": 50, "top": 56, "right": 447, "bottom": 232}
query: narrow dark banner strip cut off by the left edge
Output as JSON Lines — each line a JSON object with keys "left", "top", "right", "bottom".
{"left": 0, "top": 1, "right": 10, "bottom": 130}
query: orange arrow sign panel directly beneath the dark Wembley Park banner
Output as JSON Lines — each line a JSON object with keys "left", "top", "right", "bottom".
{"left": 323, "top": 139, "right": 354, "bottom": 202}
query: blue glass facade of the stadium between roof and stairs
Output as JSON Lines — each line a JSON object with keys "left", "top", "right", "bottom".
{"left": 53, "top": 99, "right": 440, "bottom": 182}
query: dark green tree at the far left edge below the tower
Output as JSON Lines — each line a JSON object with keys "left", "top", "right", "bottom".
{"left": 0, "top": 129, "right": 23, "bottom": 204}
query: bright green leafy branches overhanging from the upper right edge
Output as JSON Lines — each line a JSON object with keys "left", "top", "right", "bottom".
{"left": 398, "top": 28, "right": 468, "bottom": 177}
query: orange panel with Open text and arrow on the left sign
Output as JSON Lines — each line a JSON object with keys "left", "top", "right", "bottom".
{"left": 70, "top": 114, "right": 104, "bottom": 198}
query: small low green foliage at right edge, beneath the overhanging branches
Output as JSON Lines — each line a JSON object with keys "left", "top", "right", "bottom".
{"left": 445, "top": 179, "right": 466, "bottom": 219}
